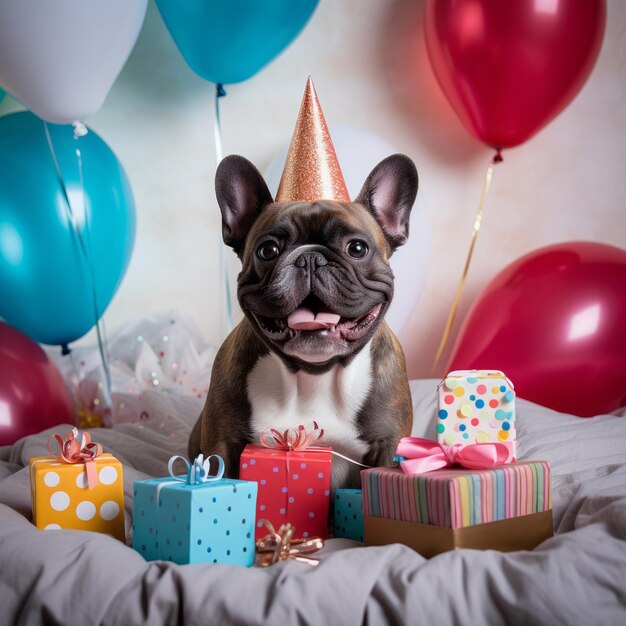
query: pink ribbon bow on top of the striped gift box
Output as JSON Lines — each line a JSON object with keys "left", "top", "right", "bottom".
{"left": 396, "top": 437, "right": 509, "bottom": 474}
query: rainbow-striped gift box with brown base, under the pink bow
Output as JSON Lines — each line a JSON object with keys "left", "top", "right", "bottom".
{"left": 361, "top": 461, "right": 552, "bottom": 556}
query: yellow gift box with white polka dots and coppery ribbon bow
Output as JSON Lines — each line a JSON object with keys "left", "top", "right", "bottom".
{"left": 30, "top": 429, "right": 125, "bottom": 541}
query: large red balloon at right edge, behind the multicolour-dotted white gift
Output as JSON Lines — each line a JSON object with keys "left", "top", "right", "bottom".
{"left": 449, "top": 242, "right": 626, "bottom": 417}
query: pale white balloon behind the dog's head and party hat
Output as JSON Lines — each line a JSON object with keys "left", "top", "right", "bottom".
{"left": 265, "top": 124, "right": 430, "bottom": 333}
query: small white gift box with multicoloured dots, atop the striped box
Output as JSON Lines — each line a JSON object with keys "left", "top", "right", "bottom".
{"left": 437, "top": 370, "right": 516, "bottom": 463}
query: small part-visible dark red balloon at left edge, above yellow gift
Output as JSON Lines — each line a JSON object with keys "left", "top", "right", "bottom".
{"left": 0, "top": 322, "right": 74, "bottom": 446}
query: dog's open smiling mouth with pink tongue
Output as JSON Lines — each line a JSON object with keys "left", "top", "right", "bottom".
{"left": 254, "top": 299, "right": 382, "bottom": 341}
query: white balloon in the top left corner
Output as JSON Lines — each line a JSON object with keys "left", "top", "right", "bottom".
{"left": 0, "top": 0, "right": 148, "bottom": 124}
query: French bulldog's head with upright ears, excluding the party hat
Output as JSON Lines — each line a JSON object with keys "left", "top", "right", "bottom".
{"left": 216, "top": 155, "right": 417, "bottom": 372}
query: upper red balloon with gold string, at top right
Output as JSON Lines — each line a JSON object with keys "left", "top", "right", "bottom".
{"left": 425, "top": 0, "right": 606, "bottom": 149}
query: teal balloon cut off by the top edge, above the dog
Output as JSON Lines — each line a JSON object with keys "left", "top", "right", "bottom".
{"left": 157, "top": 0, "right": 318, "bottom": 84}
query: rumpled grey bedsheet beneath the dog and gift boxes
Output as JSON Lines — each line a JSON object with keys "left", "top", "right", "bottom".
{"left": 0, "top": 381, "right": 626, "bottom": 626}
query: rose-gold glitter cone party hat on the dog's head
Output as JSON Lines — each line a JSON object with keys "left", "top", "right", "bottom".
{"left": 276, "top": 76, "right": 350, "bottom": 202}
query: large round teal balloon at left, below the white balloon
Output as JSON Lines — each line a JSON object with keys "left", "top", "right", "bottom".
{"left": 0, "top": 112, "right": 135, "bottom": 345}
